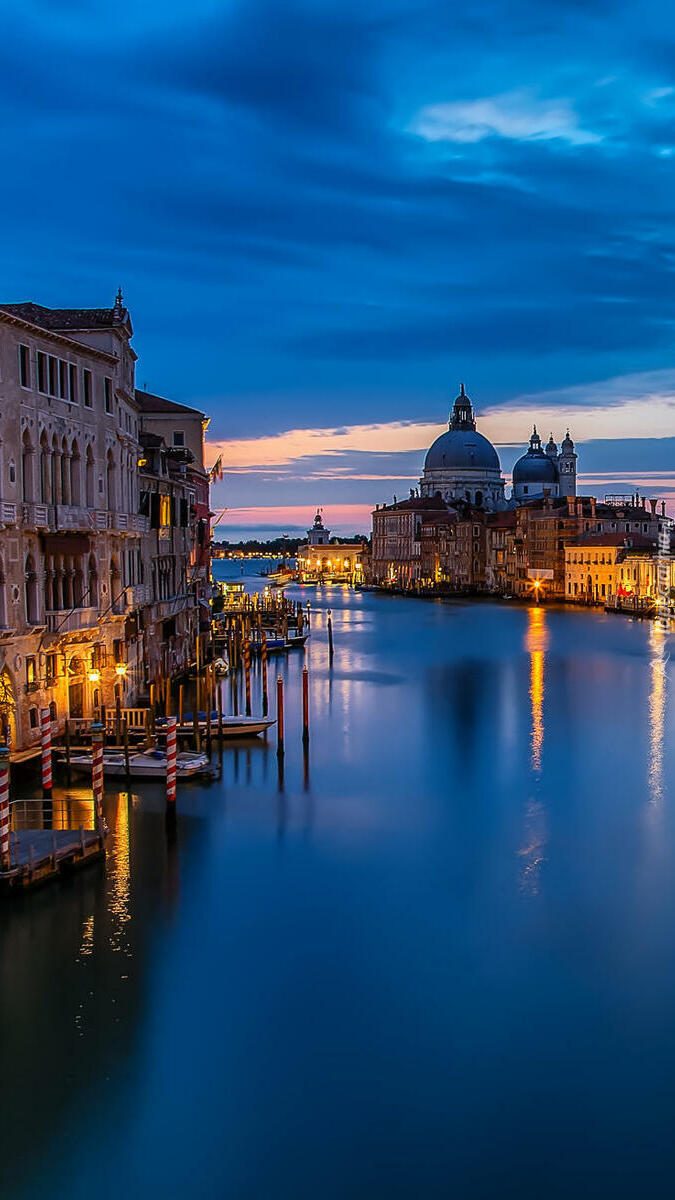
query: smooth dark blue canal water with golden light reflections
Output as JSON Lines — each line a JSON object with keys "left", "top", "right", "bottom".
{"left": 0, "top": 564, "right": 675, "bottom": 1198}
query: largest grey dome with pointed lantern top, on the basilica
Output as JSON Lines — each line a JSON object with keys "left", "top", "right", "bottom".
{"left": 419, "top": 384, "right": 506, "bottom": 510}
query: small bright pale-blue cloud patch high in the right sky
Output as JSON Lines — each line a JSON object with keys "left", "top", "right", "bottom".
{"left": 410, "top": 90, "right": 602, "bottom": 146}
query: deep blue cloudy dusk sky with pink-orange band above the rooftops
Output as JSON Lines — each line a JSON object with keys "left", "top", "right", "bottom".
{"left": 5, "top": 0, "right": 675, "bottom": 535}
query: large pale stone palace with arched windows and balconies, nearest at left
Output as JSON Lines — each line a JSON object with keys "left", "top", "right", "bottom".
{"left": 0, "top": 293, "right": 210, "bottom": 752}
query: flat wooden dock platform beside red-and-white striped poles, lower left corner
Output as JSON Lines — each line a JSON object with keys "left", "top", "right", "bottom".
{"left": 0, "top": 828, "right": 107, "bottom": 894}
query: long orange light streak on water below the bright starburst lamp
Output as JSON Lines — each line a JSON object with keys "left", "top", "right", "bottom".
{"left": 518, "top": 606, "right": 549, "bottom": 895}
